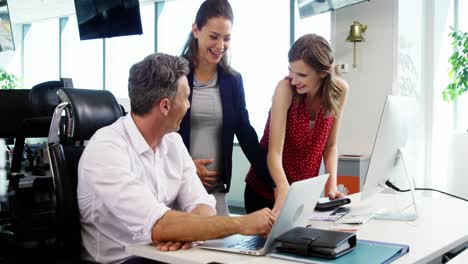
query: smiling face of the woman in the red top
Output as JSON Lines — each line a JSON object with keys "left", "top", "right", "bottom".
{"left": 289, "top": 60, "right": 327, "bottom": 95}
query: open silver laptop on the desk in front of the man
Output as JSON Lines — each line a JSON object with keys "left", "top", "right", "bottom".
{"left": 198, "top": 174, "right": 328, "bottom": 256}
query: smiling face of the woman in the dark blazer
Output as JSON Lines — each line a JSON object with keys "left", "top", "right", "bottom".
{"left": 192, "top": 17, "right": 232, "bottom": 64}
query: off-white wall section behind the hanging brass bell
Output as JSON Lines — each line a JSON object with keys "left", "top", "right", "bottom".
{"left": 332, "top": 0, "right": 397, "bottom": 155}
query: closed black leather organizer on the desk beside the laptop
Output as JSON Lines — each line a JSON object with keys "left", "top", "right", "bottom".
{"left": 277, "top": 227, "right": 356, "bottom": 259}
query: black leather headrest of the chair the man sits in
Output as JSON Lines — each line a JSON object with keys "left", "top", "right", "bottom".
{"left": 57, "top": 88, "right": 123, "bottom": 140}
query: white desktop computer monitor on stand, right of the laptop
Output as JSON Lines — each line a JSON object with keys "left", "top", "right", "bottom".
{"left": 361, "top": 95, "right": 417, "bottom": 220}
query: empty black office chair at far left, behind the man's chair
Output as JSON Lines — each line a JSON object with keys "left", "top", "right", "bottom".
{"left": 0, "top": 81, "right": 64, "bottom": 262}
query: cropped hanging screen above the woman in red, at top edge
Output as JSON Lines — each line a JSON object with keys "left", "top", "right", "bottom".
{"left": 297, "top": 0, "right": 369, "bottom": 18}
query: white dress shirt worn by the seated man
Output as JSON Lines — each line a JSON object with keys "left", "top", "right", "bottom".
{"left": 77, "top": 114, "right": 215, "bottom": 263}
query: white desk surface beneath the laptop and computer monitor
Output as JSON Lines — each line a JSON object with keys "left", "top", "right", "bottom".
{"left": 127, "top": 192, "right": 468, "bottom": 264}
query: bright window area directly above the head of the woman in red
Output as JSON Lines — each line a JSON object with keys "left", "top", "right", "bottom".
{"left": 294, "top": 9, "right": 331, "bottom": 41}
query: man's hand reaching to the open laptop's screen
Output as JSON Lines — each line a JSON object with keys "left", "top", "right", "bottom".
{"left": 241, "top": 208, "right": 276, "bottom": 236}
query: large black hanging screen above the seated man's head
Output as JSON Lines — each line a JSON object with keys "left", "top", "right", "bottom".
{"left": 75, "top": 0, "right": 143, "bottom": 40}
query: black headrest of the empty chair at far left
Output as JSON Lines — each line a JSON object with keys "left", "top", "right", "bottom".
{"left": 29, "top": 81, "right": 63, "bottom": 117}
